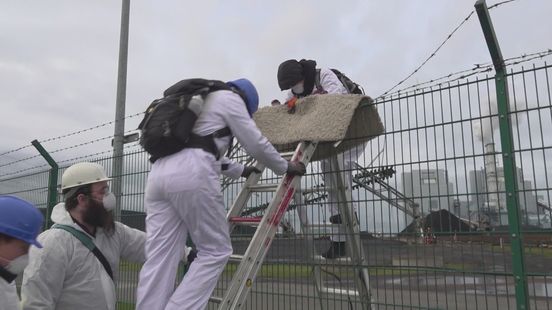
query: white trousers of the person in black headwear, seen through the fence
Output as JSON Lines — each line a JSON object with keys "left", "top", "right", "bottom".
{"left": 320, "top": 145, "right": 365, "bottom": 242}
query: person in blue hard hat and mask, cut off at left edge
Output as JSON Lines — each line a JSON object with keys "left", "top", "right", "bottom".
{"left": 0, "top": 196, "right": 43, "bottom": 310}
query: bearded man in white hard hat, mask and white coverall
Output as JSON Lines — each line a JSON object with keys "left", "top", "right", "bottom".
{"left": 21, "top": 162, "right": 146, "bottom": 310}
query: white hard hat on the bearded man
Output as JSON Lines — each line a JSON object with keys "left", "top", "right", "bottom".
{"left": 61, "top": 162, "right": 111, "bottom": 191}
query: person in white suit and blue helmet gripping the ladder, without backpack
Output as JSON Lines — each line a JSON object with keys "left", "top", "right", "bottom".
{"left": 136, "top": 79, "right": 305, "bottom": 310}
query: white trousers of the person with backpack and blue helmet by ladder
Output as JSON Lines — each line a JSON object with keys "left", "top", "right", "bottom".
{"left": 136, "top": 149, "right": 232, "bottom": 310}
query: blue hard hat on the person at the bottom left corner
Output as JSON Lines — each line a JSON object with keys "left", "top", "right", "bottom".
{"left": 0, "top": 196, "right": 44, "bottom": 248}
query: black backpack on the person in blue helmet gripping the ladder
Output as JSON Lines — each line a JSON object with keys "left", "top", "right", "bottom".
{"left": 138, "top": 79, "right": 234, "bottom": 162}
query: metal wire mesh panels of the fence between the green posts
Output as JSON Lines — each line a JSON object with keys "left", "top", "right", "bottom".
{"left": 0, "top": 62, "right": 552, "bottom": 309}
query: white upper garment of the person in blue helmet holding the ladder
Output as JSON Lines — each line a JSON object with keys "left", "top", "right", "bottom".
{"left": 193, "top": 90, "right": 287, "bottom": 178}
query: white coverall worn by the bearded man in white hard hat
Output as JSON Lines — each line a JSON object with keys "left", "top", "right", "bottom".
{"left": 21, "top": 203, "right": 146, "bottom": 310}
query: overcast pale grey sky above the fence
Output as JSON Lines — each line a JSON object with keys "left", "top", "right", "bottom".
{"left": 0, "top": 0, "right": 552, "bottom": 169}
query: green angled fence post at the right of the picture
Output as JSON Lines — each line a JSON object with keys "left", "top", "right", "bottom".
{"left": 475, "top": 0, "right": 529, "bottom": 310}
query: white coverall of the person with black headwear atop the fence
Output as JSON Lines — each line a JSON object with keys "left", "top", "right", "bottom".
{"left": 287, "top": 68, "right": 365, "bottom": 242}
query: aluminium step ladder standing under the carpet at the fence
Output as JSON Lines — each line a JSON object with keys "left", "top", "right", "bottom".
{"left": 210, "top": 142, "right": 371, "bottom": 310}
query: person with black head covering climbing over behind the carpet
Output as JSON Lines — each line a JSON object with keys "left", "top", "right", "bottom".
{"left": 277, "top": 59, "right": 365, "bottom": 259}
